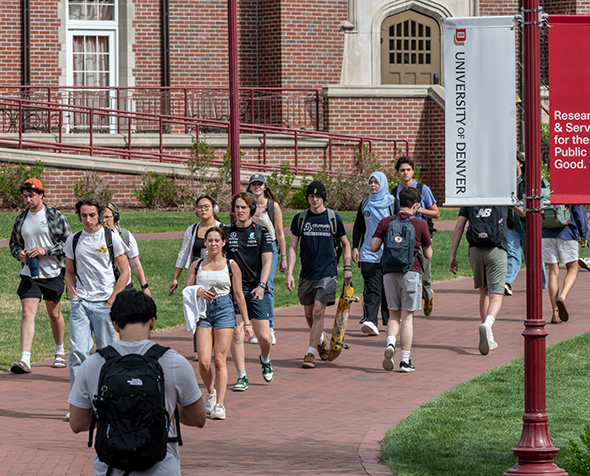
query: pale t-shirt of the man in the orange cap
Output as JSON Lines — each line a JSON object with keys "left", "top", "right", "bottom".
{"left": 20, "top": 207, "right": 61, "bottom": 279}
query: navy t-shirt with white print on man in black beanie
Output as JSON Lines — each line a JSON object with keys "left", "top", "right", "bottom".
{"left": 291, "top": 210, "right": 346, "bottom": 279}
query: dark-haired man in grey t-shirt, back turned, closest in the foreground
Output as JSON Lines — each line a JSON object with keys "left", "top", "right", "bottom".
{"left": 68, "top": 291, "right": 206, "bottom": 476}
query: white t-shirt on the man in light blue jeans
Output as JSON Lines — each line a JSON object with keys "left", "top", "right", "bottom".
{"left": 64, "top": 227, "right": 129, "bottom": 302}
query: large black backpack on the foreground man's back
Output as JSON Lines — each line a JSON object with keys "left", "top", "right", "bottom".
{"left": 88, "top": 344, "right": 182, "bottom": 475}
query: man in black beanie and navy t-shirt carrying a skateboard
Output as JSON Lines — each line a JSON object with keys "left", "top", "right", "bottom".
{"left": 286, "top": 180, "right": 352, "bottom": 369}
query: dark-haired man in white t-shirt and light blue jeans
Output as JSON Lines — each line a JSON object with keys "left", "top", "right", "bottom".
{"left": 64, "top": 198, "right": 129, "bottom": 386}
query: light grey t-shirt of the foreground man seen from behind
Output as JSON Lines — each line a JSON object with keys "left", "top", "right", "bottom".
{"left": 68, "top": 340, "right": 202, "bottom": 476}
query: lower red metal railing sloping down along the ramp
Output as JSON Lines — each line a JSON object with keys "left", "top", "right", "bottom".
{"left": 0, "top": 97, "right": 409, "bottom": 174}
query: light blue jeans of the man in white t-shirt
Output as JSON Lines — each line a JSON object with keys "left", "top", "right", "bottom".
{"left": 69, "top": 297, "right": 115, "bottom": 388}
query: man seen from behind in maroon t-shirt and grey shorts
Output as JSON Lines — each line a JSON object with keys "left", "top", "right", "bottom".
{"left": 371, "top": 187, "right": 432, "bottom": 372}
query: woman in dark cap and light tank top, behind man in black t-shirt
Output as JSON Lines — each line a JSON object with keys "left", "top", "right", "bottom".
{"left": 247, "top": 174, "right": 287, "bottom": 344}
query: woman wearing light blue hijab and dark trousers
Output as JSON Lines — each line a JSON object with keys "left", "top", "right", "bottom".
{"left": 352, "top": 172, "right": 399, "bottom": 336}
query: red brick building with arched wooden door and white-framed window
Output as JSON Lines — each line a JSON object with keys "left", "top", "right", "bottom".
{"left": 0, "top": 0, "right": 590, "bottom": 207}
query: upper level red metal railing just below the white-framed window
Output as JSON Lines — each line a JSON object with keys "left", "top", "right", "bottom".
{"left": 0, "top": 85, "right": 323, "bottom": 132}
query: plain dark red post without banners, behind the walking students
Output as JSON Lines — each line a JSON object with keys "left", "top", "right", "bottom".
{"left": 227, "top": 0, "right": 241, "bottom": 195}
